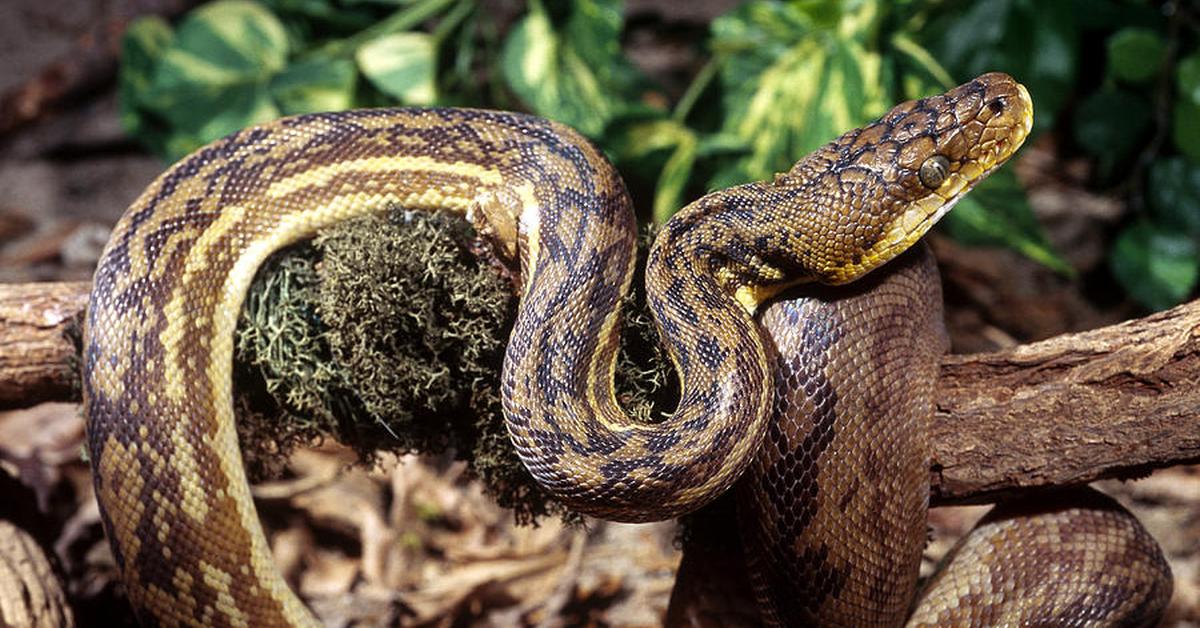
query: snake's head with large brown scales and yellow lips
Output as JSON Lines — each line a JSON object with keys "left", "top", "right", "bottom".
{"left": 785, "top": 72, "right": 1033, "bottom": 283}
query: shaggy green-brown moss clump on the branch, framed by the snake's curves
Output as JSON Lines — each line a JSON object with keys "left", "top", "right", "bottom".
{"left": 235, "top": 210, "right": 678, "bottom": 521}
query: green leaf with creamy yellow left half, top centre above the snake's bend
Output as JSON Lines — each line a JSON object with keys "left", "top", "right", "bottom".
{"left": 500, "top": 0, "right": 638, "bottom": 137}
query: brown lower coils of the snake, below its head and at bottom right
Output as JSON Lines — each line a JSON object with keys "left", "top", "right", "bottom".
{"left": 667, "top": 245, "right": 1172, "bottom": 627}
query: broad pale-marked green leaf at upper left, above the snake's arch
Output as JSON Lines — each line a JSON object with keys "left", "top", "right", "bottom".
{"left": 143, "top": 0, "right": 288, "bottom": 159}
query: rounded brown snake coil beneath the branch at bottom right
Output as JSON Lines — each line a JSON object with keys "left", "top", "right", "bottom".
{"left": 908, "top": 489, "right": 1172, "bottom": 627}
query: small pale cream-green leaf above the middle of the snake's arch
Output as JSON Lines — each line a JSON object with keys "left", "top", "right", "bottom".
{"left": 355, "top": 32, "right": 438, "bottom": 104}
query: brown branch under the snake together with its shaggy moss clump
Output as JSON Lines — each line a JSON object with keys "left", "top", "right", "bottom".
{"left": 0, "top": 211, "right": 1200, "bottom": 518}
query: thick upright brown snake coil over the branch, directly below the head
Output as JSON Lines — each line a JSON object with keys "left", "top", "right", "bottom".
{"left": 738, "top": 246, "right": 948, "bottom": 626}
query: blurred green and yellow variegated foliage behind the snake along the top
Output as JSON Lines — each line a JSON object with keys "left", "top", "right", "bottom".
{"left": 120, "top": 0, "right": 1200, "bottom": 309}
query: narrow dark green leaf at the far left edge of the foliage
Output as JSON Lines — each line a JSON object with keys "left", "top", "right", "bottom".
{"left": 118, "top": 16, "right": 174, "bottom": 152}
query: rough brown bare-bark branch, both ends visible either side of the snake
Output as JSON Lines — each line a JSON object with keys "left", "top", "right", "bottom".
{"left": 0, "top": 283, "right": 1200, "bottom": 506}
